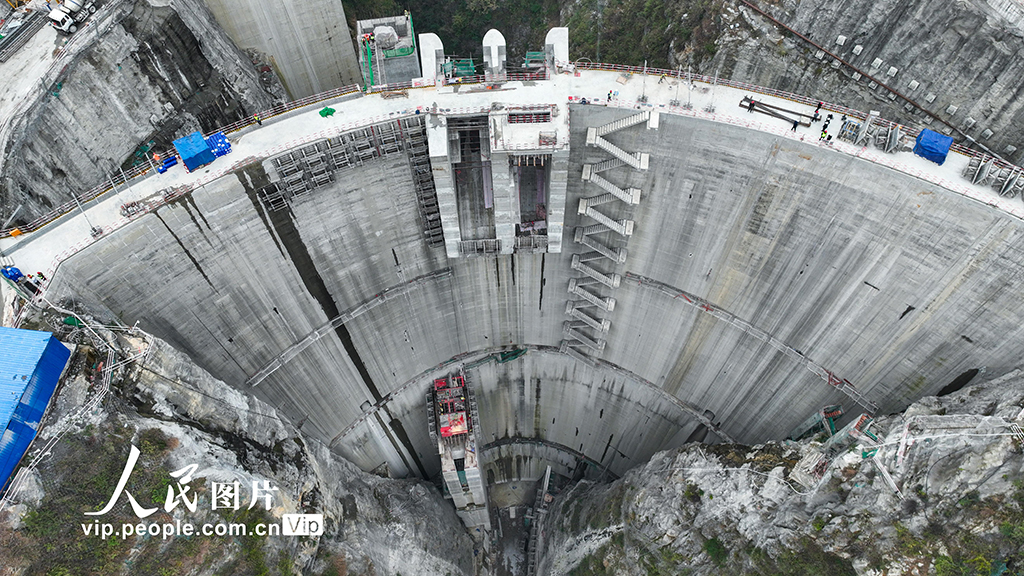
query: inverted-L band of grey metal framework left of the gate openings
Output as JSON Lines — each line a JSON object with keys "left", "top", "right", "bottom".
{"left": 258, "top": 116, "right": 444, "bottom": 247}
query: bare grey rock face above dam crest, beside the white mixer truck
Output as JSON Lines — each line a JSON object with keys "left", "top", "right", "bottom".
{"left": 0, "top": 0, "right": 271, "bottom": 222}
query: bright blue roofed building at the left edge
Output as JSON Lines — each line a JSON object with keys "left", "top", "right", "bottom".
{"left": 0, "top": 326, "right": 71, "bottom": 488}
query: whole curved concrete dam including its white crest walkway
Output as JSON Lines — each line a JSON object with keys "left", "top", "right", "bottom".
{"left": 3, "top": 29, "right": 1024, "bottom": 506}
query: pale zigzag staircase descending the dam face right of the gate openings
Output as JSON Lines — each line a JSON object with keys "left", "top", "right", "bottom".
{"left": 559, "top": 111, "right": 657, "bottom": 364}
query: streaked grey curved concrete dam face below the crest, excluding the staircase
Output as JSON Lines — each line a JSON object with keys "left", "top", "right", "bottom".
{"left": 44, "top": 101, "right": 1024, "bottom": 482}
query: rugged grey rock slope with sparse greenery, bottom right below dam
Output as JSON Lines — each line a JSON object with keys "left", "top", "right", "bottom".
{"left": 542, "top": 371, "right": 1024, "bottom": 575}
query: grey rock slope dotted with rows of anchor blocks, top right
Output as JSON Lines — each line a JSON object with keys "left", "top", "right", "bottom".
{"left": 706, "top": 0, "right": 1024, "bottom": 164}
